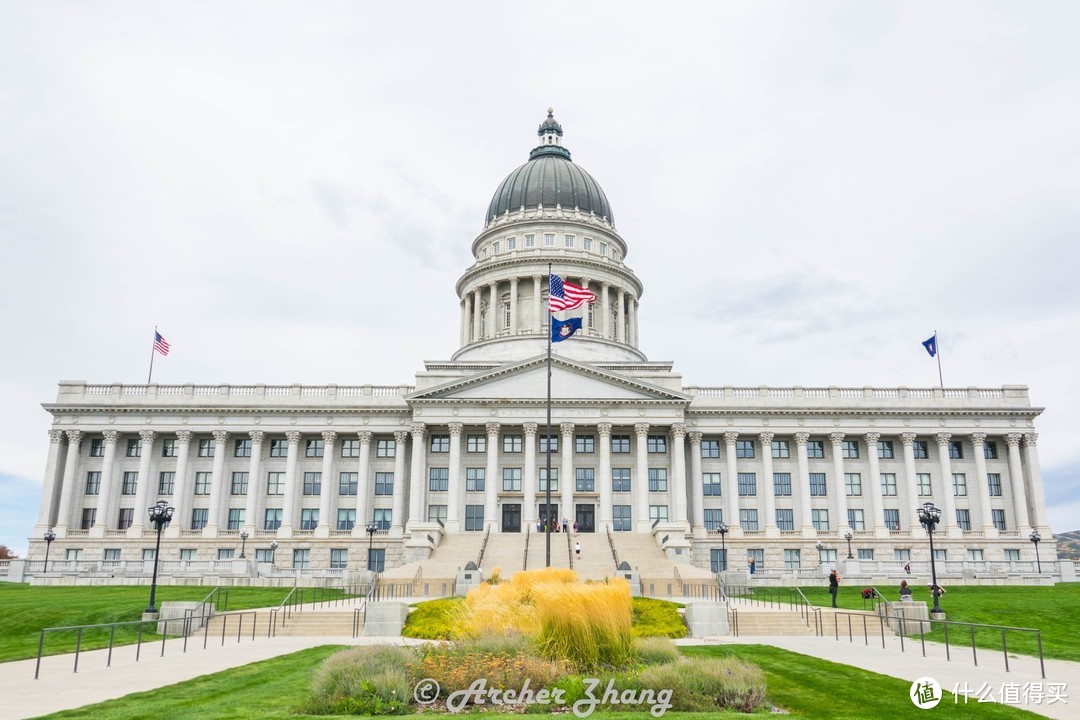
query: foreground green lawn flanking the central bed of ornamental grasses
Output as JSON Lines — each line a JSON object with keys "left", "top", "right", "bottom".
{"left": 33, "top": 646, "right": 1039, "bottom": 720}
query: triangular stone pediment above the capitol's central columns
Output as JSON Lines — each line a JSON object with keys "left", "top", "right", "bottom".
{"left": 406, "top": 355, "right": 690, "bottom": 405}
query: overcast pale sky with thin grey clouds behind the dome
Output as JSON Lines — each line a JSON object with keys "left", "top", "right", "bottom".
{"left": 0, "top": 0, "right": 1080, "bottom": 553}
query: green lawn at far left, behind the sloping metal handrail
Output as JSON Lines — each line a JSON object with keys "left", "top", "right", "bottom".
{"left": 0, "top": 583, "right": 289, "bottom": 662}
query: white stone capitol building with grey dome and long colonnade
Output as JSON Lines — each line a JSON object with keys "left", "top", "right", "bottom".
{"left": 23, "top": 112, "right": 1056, "bottom": 578}
